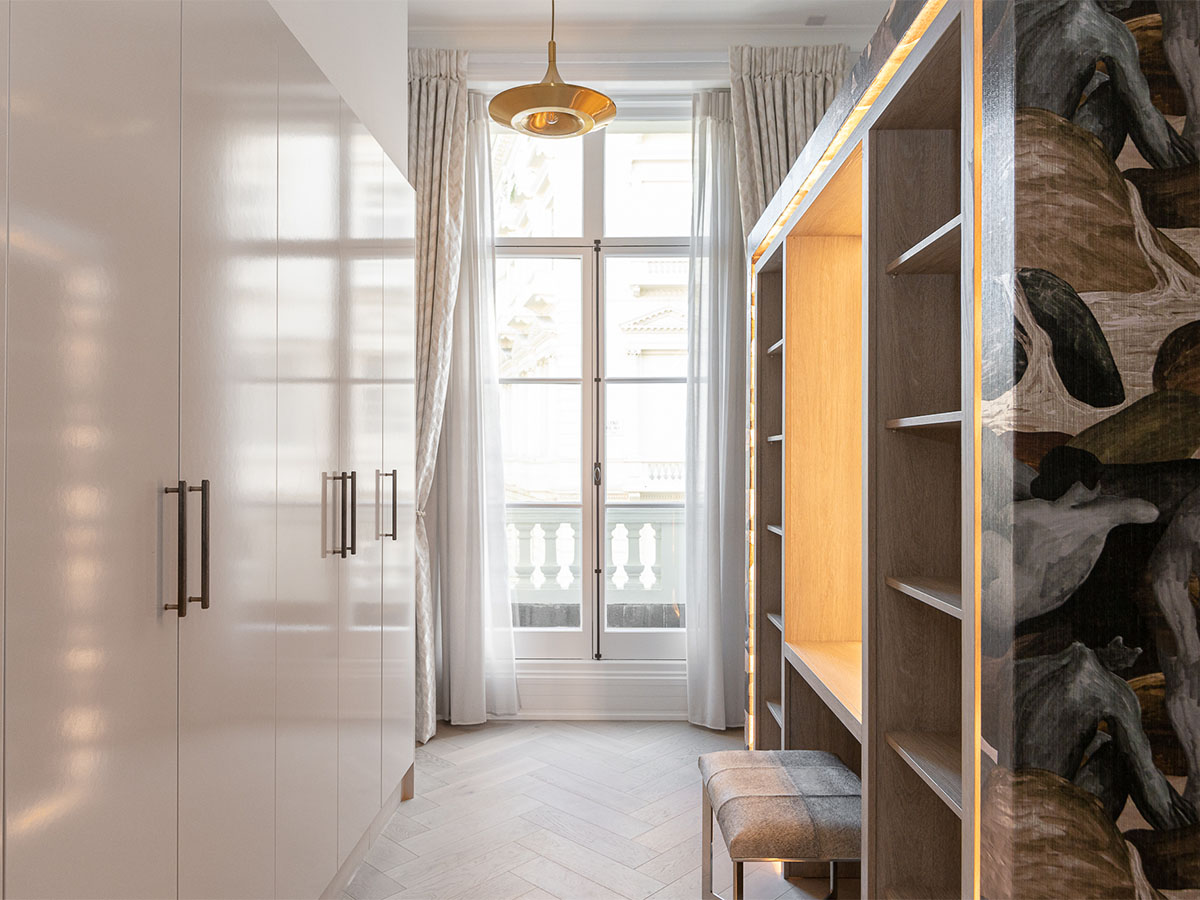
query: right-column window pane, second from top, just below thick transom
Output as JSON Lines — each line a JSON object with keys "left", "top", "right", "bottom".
{"left": 604, "top": 257, "right": 688, "bottom": 378}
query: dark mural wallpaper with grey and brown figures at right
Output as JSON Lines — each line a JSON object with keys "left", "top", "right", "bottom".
{"left": 982, "top": 0, "right": 1200, "bottom": 898}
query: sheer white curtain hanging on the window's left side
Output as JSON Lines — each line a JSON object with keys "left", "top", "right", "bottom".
{"left": 428, "top": 92, "right": 517, "bottom": 725}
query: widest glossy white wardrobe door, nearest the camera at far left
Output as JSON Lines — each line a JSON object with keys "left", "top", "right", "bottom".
{"left": 4, "top": 1, "right": 180, "bottom": 898}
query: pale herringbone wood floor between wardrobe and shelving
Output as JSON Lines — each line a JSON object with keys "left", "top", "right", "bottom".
{"left": 347, "top": 722, "right": 857, "bottom": 900}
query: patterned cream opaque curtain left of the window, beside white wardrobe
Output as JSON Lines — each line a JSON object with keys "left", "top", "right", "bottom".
{"left": 408, "top": 49, "right": 467, "bottom": 743}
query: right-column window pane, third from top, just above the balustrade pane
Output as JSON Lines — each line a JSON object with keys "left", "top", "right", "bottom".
{"left": 604, "top": 384, "right": 688, "bottom": 503}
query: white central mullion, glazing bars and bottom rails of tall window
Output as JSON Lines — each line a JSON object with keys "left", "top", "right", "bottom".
{"left": 496, "top": 123, "right": 689, "bottom": 660}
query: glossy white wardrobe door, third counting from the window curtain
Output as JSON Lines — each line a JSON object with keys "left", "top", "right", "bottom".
{"left": 275, "top": 31, "right": 341, "bottom": 898}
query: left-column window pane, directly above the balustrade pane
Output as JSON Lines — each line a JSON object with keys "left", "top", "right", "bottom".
{"left": 500, "top": 384, "right": 583, "bottom": 503}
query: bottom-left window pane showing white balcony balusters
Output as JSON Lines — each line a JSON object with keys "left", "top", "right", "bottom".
{"left": 504, "top": 506, "right": 583, "bottom": 631}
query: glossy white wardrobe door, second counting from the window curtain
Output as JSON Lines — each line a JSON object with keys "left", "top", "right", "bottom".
{"left": 337, "top": 102, "right": 383, "bottom": 865}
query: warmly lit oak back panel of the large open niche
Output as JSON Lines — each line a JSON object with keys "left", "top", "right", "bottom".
{"left": 784, "top": 150, "right": 863, "bottom": 642}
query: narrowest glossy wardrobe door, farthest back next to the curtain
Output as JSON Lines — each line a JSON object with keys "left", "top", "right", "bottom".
{"left": 380, "top": 157, "right": 416, "bottom": 800}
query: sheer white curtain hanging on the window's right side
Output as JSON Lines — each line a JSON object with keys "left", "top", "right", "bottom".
{"left": 684, "top": 91, "right": 746, "bottom": 728}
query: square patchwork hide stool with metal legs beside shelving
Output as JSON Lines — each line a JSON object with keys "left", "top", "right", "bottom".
{"left": 700, "top": 750, "right": 863, "bottom": 900}
